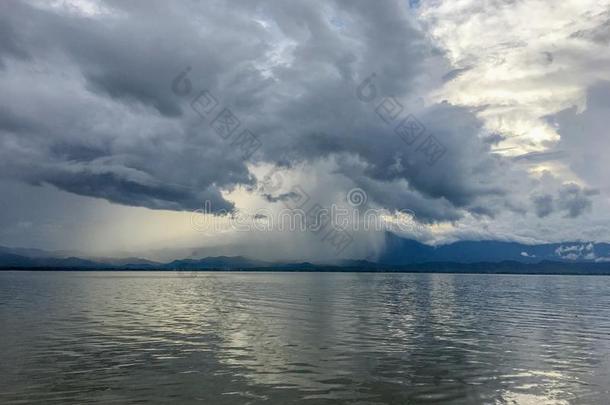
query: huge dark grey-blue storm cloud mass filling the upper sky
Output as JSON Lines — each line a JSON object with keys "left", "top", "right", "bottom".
{"left": 0, "top": 1, "right": 540, "bottom": 222}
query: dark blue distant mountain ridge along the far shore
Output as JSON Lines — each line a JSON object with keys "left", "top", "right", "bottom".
{"left": 0, "top": 233, "right": 610, "bottom": 271}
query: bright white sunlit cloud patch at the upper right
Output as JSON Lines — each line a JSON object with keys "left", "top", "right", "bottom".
{"left": 422, "top": 0, "right": 610, "bottom": 154}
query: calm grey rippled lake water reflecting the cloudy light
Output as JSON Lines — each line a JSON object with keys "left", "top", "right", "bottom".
{"left": 0, "top": 272, "right": 610, "bottom": 404}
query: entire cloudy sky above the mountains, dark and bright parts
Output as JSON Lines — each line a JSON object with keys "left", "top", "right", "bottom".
{"left": 0, "top": 0, "right": 610, "bottom": 260}
